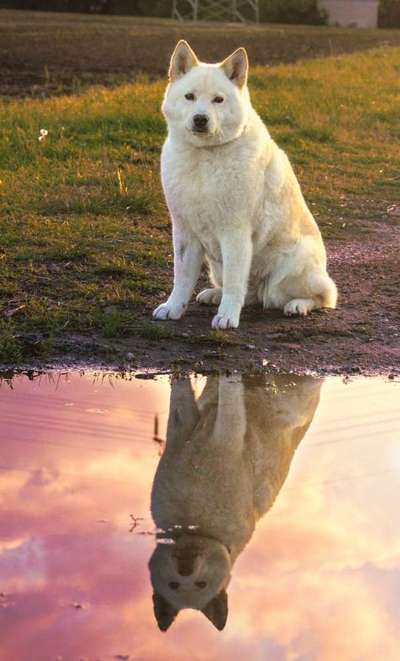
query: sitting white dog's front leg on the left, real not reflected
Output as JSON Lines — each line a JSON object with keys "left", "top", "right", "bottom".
{"left": 153, "top": 227, "right": 204, "bottom": 319}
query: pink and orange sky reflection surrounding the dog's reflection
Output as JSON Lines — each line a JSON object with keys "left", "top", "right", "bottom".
{"left": 0, "top": 374, "right": 400, "bottom": 661}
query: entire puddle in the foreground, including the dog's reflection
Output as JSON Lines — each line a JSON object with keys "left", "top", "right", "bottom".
{"left": 0, "top": 373, "right": 400, "bottom": 661}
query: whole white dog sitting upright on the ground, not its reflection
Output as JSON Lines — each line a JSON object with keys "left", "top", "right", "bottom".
{"left": 153, "top": 41, "right": 337, "bottom": 328}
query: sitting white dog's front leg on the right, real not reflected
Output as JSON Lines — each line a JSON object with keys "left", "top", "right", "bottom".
{"left": 212, "top": 231, "right": 252, "bottom": 328}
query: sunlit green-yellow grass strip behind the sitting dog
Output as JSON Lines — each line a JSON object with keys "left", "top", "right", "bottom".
{"left": 0, "top": 48, "right": 400, "bottom": 361}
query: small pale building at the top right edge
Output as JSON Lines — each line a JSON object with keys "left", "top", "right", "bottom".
{"left": 319, "top": 0, "right": 379, "bottom": 28}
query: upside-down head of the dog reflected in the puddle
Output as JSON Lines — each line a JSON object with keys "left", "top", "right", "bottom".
{"left": 149, "top": 534, "right": 231, "bottom": 631}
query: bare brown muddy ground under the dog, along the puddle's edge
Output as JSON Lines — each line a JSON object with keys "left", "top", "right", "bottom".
{"left": 14, "top": 223, "right": 400, "bottom": 376}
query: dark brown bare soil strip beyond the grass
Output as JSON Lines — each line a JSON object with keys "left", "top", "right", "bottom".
{"left": 0, "top": 10, "right": 400, "bottom": 97}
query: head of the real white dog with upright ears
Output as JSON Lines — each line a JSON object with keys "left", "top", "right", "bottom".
{"left": 162, "top": 41, "right": 250, "bottom": 147}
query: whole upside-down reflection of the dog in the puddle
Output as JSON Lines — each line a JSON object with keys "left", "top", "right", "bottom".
{"left": 149, "top": 376, "right": 322, "bottom": 631}
